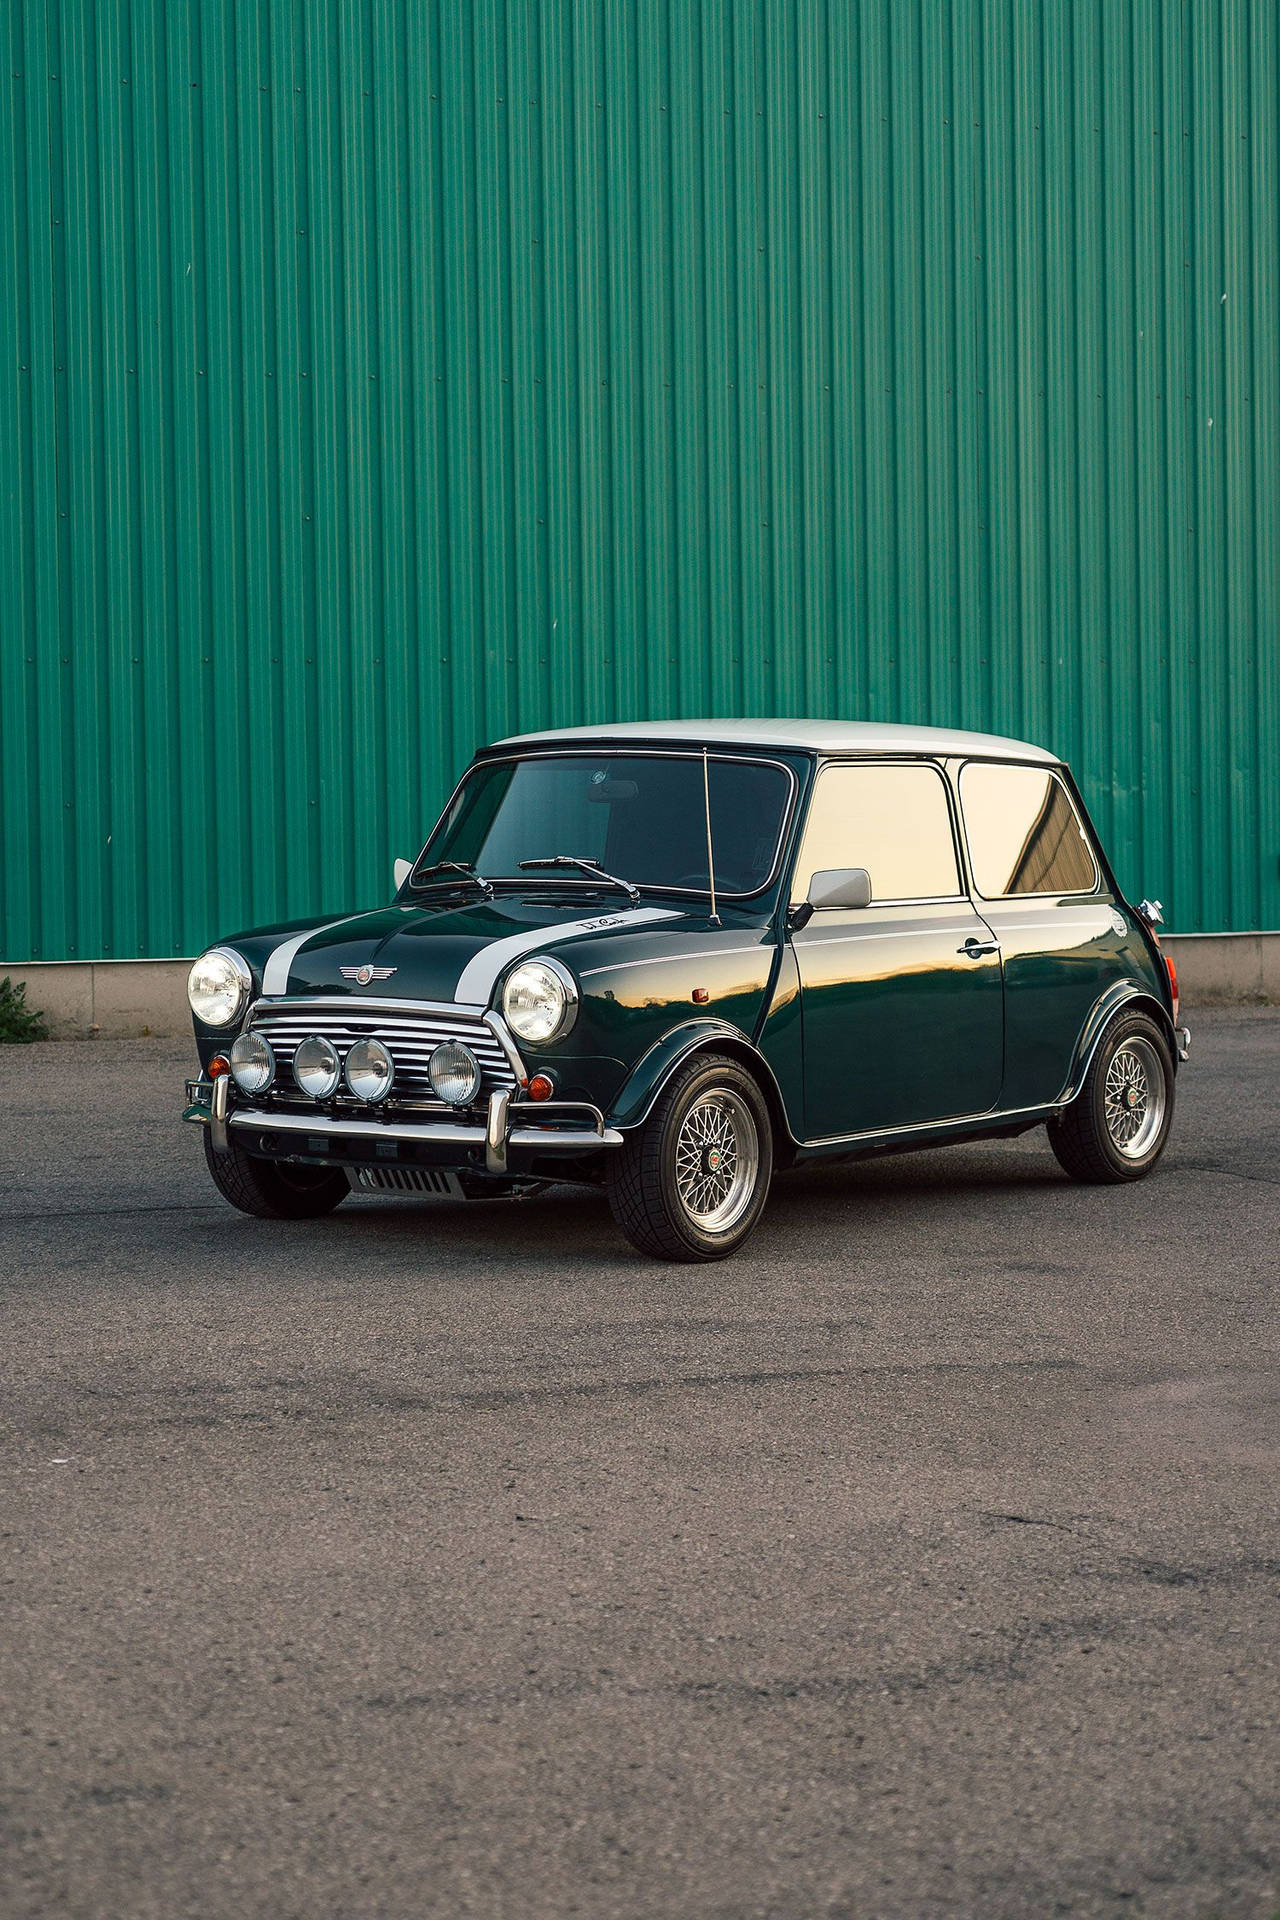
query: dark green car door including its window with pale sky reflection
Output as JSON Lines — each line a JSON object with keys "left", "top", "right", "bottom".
{"left": 791, "top": 760, "right": 1004, "bottom": 1140}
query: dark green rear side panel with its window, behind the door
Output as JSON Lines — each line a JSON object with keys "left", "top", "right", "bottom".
{"left": 958, "top": 760, "right": 1130, "bottom": 1108}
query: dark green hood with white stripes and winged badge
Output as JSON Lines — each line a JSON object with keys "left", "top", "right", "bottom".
{"left": 243, "top": 895, "right": 694, "bottom": 1006}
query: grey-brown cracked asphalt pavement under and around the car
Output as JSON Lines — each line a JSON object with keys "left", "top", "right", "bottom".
{"left": 0, "top": 1008, "right": 1280, "bottom": 1920}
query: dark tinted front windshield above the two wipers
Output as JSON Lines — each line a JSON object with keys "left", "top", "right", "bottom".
{"left": 411, "top": 753, "right": 791, "bottom": 895}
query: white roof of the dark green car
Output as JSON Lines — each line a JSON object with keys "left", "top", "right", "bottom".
{"left": 495, "top": 720, "right": 1059, "bottom": 766}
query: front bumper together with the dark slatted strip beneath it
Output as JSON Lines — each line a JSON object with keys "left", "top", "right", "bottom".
{"left": 182, "top": 1073, "right": 622, "bottom": 1173}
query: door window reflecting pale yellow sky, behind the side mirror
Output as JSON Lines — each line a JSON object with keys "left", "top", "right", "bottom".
{"left": 794, "top": 764, "right": 960, "bottom": 900}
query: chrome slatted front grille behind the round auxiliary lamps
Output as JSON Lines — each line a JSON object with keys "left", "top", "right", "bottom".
{"left": 249, "top": 998, "right": 516, "bottom": 1106}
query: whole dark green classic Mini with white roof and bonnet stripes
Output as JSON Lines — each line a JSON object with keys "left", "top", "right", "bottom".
{"left": 186, "top": 720, "right": 1190, "bottom": 1260}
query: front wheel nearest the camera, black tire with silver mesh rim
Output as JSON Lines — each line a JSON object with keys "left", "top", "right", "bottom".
{"left": 606, "top": 1054, "right": 773, "bottom": 1260}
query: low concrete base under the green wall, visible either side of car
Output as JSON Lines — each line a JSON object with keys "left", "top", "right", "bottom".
{"left": 0, "top": 933, "right": 1280, "bottom": 1041}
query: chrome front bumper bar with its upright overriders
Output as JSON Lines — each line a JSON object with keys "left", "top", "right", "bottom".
{"left": 182, "top": 1075, "right": 622, "bottom": 1173}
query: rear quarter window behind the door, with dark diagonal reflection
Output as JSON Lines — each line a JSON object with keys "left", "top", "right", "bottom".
{"left": 960, "top": 760, "right": 1098, "bottom": 900}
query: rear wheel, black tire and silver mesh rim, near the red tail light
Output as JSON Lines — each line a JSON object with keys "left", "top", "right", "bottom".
{"left": 1048, "top": 1012, "right": 1174, "bottom": 1187}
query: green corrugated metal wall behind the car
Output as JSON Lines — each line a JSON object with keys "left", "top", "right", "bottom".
{"left": 0, "top": 0, "right": 1280, "bottom": 960}
